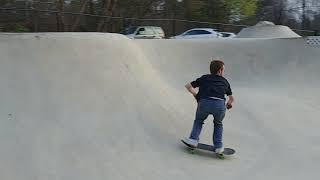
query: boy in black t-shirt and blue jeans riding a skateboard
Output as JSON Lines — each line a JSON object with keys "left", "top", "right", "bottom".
{"left": 184, "top": 60, "right": 234, "bottom": 154}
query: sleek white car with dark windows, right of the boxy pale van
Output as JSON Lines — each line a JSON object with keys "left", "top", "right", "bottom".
{"left": 171, "top": 28, "right": 222, "bottom": 39}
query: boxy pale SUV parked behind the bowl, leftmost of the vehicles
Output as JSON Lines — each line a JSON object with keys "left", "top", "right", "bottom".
{"left": 120, "top": 26, "right": 165, "bottom": 39}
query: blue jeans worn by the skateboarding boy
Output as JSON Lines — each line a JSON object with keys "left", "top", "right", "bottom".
{"left": 190, "top": 99, "right": 226, "bottom": 148}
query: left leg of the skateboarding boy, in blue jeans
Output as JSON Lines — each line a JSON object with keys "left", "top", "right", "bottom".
{"left": 190, "top": 102, "right": 209, "bottom": 141}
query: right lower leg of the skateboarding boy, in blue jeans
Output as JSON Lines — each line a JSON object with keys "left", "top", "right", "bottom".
{"left": 213, "top": 110, "right": 226, "bottom": 148}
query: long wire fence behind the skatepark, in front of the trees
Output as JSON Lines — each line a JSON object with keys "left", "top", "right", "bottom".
{"left": 0, "top": 8, "right": 320, "bottom": 36}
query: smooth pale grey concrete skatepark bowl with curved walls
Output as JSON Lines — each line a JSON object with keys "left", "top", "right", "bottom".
{"left": 0, "top": 23, "right": 320, "bottom": 180}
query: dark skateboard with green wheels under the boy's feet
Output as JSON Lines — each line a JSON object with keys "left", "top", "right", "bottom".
{"left": 181, "top": 139, "right": 236, "bottom": 159}
